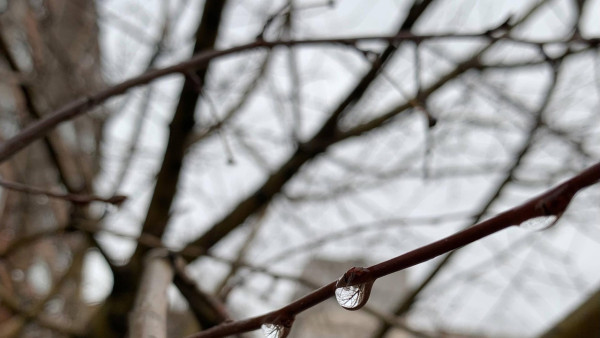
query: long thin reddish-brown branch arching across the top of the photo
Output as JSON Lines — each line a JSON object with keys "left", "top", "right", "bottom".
{"left": 0, "top": 30, "right": 600, "bottom": 163}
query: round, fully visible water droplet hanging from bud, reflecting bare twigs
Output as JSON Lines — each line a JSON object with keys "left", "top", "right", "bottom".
{"left": 335, "top": 267, "right": 373, "bottom": 311}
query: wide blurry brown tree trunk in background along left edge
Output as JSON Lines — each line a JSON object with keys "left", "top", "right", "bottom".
{"left": 0, "top": 0, "right": 105, "bottom": 336}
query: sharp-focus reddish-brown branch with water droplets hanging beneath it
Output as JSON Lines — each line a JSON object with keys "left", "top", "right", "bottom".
{"left": 190, "top": 163, "right": 600, "bottom": 338}
